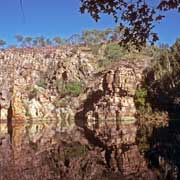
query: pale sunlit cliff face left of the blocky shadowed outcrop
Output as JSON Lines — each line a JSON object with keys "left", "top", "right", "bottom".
{"left": 0, "top": 47, "right": 96, "bottom": 138}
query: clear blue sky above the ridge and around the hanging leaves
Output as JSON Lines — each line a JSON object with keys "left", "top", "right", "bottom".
{"left": 0, "top": 0, "right": 180, "bottom": 44}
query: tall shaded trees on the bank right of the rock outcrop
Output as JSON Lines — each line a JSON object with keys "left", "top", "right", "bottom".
{"left": 145, "top": 39, "right": 180, "bottom": 111}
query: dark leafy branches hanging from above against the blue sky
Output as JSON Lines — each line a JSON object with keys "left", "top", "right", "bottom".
{"left": 80, "top": 0, "right": 180, "bottom": 49}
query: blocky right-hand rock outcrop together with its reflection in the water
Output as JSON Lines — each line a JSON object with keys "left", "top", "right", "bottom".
{"left": 76, "top": 61, "right": 155, "bottom": 179}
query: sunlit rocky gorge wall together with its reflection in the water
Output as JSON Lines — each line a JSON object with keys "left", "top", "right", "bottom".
{"left": 0, "top": 47, "right": 156, "bottom": 179}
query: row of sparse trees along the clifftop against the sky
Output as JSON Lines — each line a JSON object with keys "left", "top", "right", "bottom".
{"left": 5, "top": 25, "right": 150, "bottom": 48}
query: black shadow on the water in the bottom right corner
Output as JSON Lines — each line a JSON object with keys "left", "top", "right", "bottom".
{"left": 146, "top": 112, "right": 180, "bottom": 180}
